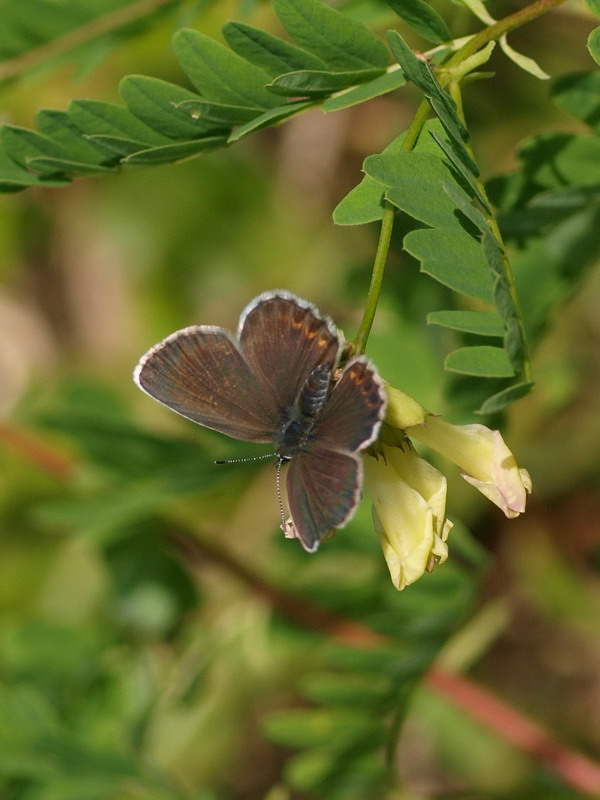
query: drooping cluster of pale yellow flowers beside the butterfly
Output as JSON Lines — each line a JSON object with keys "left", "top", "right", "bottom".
{"left": 365, "top": 386, "right": 531, "bottom": 589}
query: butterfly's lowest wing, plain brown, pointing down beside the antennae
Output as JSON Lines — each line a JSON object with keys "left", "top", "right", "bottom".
{"left": 286, "top": 446, "right": 362, "bottom": 553}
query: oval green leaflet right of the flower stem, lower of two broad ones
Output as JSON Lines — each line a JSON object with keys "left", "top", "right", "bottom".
{"left": 404, "top": 228, "right": 494, "bottom": 303}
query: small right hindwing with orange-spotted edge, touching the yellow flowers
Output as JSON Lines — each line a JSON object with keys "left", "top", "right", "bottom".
{"left": 309, "top": 356, "right": 386, "bottom": 452}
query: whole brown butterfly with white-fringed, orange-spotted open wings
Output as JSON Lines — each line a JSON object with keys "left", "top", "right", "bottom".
{"left": 134, "top": 290, "right": 386, "bottom": 552}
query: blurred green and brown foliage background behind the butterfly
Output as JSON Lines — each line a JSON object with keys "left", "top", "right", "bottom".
{"left": 0, "top": 2, "right": 600, "bottom": 800}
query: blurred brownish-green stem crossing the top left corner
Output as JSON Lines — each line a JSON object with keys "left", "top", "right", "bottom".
{"left": 0, "top": 0, "right": 180, "bottom": 83}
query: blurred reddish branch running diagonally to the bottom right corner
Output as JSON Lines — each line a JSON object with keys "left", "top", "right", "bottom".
{"left": 170, "top": 530, "right": 600, "bottom": 797}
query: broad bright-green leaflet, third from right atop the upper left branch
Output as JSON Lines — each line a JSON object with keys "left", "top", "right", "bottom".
{"left": 173, "top": 28, "right": 278, "bottom": 110}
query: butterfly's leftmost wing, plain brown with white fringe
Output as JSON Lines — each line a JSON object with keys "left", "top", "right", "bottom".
{"left": 134, "top": 325, "right": 281, "bottom": 442}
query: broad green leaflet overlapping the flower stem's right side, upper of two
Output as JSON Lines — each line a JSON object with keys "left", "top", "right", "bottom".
{"left": 364, "top": 151, "right": 462, "bottom": 228}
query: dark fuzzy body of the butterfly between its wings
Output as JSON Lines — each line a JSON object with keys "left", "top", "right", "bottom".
{"left": 277, "top": 364, "right": 332, "bottom": 461}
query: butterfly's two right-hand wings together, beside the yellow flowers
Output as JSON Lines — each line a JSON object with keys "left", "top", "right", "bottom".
{"left": 286, "top": 356, "right": 386, "bottom": 552}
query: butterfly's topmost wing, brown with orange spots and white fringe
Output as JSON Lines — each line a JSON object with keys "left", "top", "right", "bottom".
{"left": 239, "top": 291, "right": 339, "bottom": 411}
